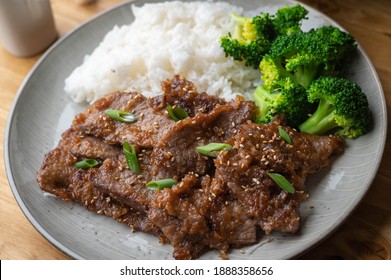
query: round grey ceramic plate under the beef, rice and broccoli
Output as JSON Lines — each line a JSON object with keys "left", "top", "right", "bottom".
{"left": 4, "top": 0, "right": 386, "bottom": 259}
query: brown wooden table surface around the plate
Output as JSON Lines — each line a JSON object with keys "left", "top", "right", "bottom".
{"left": 0, "top": 0, "right": 391, "bottom": 259}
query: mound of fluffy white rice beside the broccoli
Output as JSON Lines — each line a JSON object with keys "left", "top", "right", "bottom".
{"left": 65, "top": 1, "right": 260, "bottom": 103}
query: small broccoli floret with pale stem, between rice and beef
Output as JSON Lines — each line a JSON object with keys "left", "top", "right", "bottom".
{"left": 254, "top": 75, "right": 313, "bottom": 127}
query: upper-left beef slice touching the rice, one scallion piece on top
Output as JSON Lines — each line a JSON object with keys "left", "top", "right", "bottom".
{"left": 72, "top": 92, "right": 175, "bottom": 148}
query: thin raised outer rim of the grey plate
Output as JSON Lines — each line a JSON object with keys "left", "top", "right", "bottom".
{"left": 3, "top": 0, "right": 388, "bottom": 259}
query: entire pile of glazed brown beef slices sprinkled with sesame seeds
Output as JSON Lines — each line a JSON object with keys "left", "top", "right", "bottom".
{"left": 37, "top": 76, "right": 344, "bottom": 259}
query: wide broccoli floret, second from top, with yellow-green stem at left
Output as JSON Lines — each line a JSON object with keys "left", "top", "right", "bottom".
{"left": 260, "top": 26, "right": 357, "bottom": 89}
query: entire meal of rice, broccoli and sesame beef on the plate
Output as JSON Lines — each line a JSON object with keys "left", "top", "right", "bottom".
{"left": 37, "top": 1, "right": 370, "bottom": 259}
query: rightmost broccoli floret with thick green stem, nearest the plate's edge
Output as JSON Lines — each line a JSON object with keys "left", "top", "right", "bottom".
{"left": 299, "top": 76, "right": 371, "bottom": 138}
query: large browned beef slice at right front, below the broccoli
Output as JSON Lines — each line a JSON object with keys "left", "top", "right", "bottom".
{"left": 149, "top": 118, "right": 343, "bottom": 259}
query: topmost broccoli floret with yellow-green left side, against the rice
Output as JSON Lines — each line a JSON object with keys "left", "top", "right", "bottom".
{"left": 220, "top": 5, "right": 308, "bottom": 69}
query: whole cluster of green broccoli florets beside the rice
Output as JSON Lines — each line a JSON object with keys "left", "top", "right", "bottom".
{"left": 220, "top": 5, "right": 371, "bottom": 138}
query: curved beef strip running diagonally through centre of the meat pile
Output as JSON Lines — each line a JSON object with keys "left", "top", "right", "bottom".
{"left": 151, "top": 98, "right": 256, "bottom": 180}
